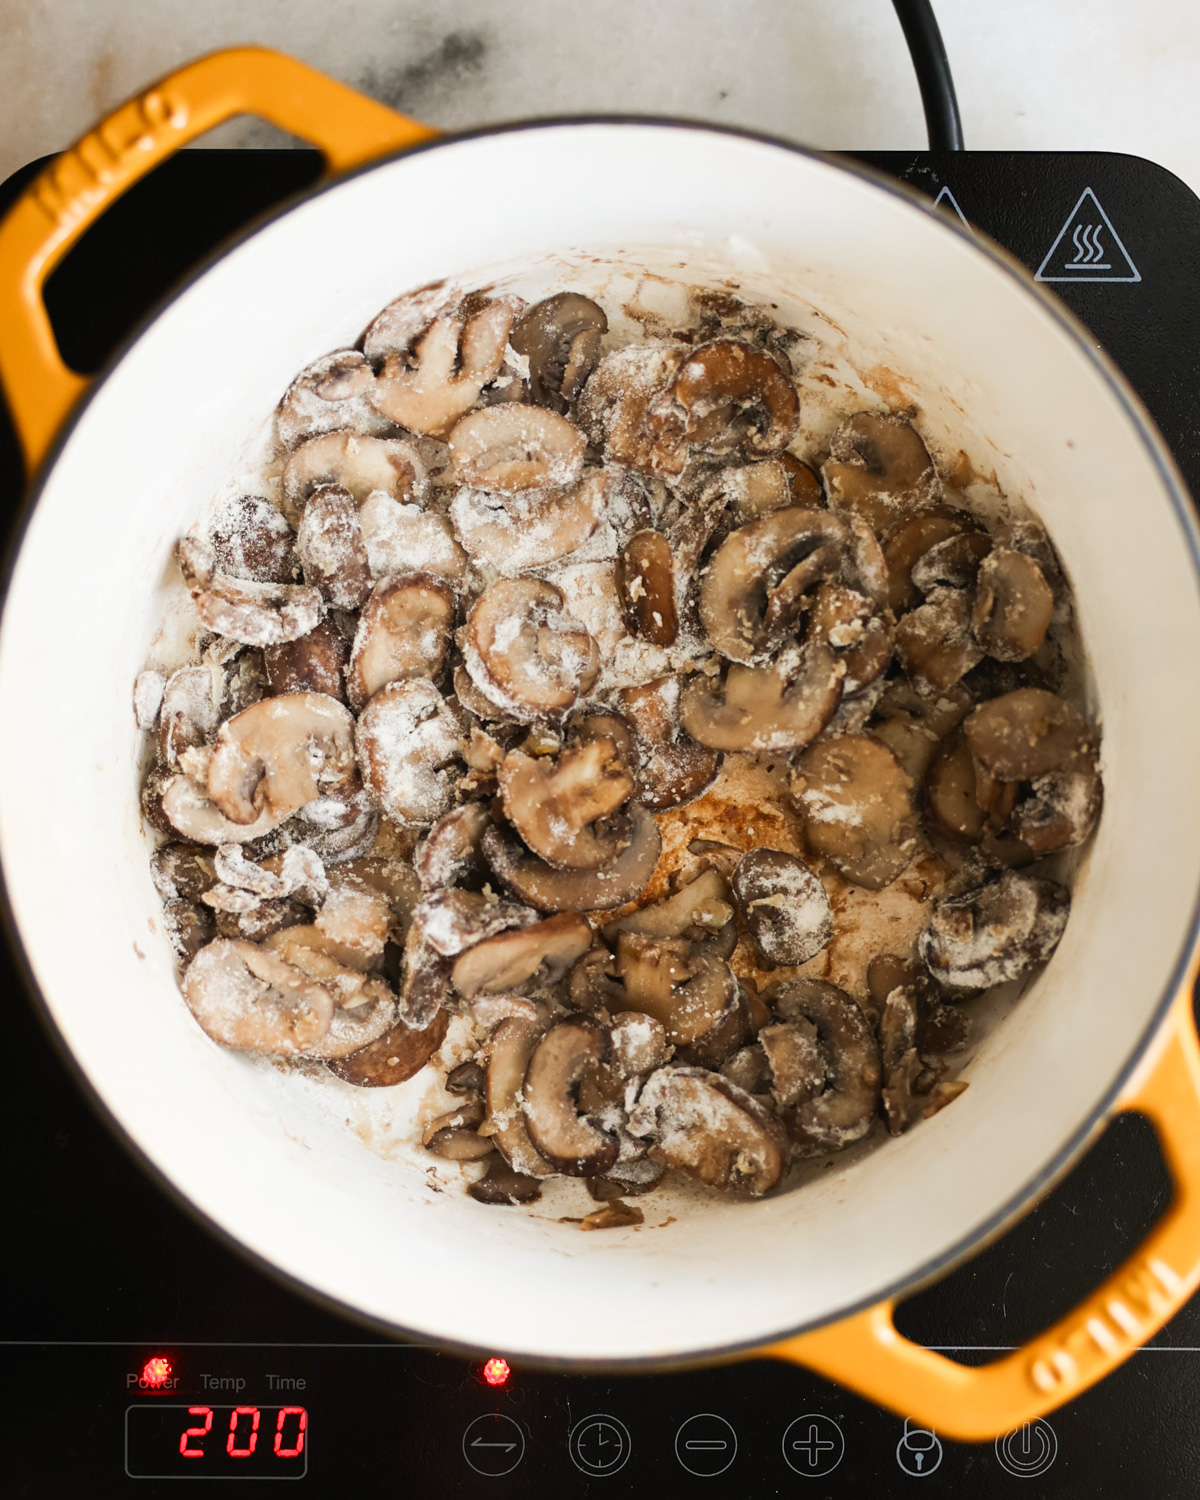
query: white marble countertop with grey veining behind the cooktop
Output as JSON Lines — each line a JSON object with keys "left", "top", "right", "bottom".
{"left": 0, "top": 0, "right": 1200, "bottom": 194}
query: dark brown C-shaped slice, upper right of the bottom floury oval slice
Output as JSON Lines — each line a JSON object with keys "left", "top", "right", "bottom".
{"left": 764, "top": 980, "right": 881, "bottom": 1152}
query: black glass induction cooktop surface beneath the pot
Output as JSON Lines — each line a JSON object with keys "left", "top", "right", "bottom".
{"left": 0, "top": 143, "right": 1200, "bottom": 1500}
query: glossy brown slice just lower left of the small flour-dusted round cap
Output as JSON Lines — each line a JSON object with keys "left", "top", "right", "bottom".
{"left": 609, "top": 932, "right": 738, "bottom": 1052}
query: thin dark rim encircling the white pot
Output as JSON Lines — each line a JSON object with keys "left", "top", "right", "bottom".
{"left": 0, "top": 113, "right": 1200, "bottom": 1374}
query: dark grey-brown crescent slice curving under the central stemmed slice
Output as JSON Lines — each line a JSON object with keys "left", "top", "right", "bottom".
{"left": 480, "top": 803, "right": 663, "bottom": 912}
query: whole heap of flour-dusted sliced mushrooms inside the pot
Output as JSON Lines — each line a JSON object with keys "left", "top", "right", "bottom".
{"left": 134, "top": 284, "right": 1103, "bottom": 1229}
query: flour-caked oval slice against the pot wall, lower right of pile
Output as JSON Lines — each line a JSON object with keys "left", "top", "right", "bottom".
{"left": 917, "top": 870, "right": 1071, "bottom": 990}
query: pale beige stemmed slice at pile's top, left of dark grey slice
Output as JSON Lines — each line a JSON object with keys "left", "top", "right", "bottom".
{"left": 367, "top": 302, "right": 513, "bottom": 438}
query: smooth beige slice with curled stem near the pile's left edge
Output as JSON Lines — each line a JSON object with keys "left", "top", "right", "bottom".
{"left": 209, "top": 693, "right": 356, "bottom": 843}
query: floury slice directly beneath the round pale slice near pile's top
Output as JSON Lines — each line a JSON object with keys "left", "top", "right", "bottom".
{"left": 450, "top": 468, "right": 618, "bottom": 578}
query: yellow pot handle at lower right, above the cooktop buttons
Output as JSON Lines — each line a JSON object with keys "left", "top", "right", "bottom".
{"left": 761, "top": 975, "right": 1200, "bottom": 1442}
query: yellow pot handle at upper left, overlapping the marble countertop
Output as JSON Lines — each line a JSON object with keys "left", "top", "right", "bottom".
{"left": 0, "top": 47, "right": 438, "bottom": 474}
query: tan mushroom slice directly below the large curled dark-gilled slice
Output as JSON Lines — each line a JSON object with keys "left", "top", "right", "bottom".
{"left": 680, "top": 642, "right": 846, "bottom": 762}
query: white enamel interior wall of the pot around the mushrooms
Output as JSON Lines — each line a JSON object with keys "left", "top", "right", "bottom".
{"left": 0, "top": 122, "right": 1200, "bottom": 1364}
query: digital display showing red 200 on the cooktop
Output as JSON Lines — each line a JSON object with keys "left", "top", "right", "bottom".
{"left": 125, "top": 1401, "right": 309, "bottom": 1479}
